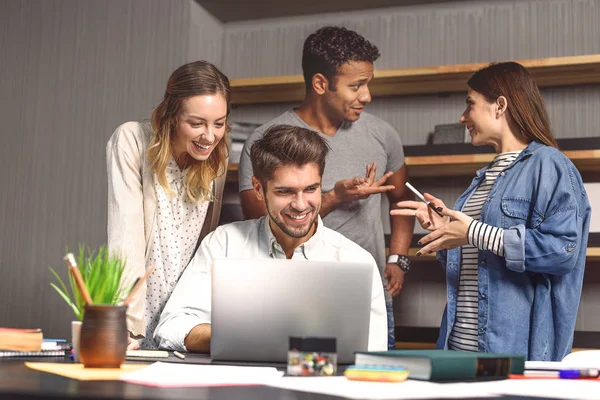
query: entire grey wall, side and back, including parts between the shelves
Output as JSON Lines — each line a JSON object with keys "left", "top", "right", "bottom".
{"left": 0, "top": 0, "right": 600, "bottom": 337}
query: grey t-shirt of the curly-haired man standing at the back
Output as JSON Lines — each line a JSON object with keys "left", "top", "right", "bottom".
{"left": 238, "top": 109, "right": 404, "bottom": 282}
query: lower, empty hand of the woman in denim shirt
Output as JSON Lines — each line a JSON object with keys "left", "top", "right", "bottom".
{"left": 417, "top": 207, "right": 473, "bottom": 256}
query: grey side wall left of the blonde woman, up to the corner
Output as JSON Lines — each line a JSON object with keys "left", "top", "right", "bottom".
{"left": 0, "top": 0, "right": 223, "bottom": 337}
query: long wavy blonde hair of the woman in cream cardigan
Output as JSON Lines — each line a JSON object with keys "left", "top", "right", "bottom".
{"left": 147, "top": 61, "right": 231, "bottom": 202}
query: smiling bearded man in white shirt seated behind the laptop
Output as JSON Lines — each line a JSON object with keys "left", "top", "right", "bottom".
{"left": 154, "top": 125, "right": 387, "bottom": 352}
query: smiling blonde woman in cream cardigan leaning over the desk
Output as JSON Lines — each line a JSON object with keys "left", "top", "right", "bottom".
{"left": 106, "top": 61, "right": 231, "bottom": 349}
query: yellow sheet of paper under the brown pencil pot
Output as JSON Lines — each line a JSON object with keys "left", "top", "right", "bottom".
{"left": 25, "top": 362, "right": 147, "bottom": 381}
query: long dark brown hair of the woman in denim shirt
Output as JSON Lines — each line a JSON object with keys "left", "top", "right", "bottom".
{"left": 467, "top": 61, "right": 558, "bottom": 147}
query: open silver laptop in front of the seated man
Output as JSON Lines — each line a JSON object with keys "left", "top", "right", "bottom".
{"left": 210, "top": 259, "right": 373, "bottom": 364}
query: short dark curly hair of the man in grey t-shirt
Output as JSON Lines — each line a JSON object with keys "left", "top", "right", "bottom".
{"left": 302, "top": 26, "right": 381, "bottom": 93}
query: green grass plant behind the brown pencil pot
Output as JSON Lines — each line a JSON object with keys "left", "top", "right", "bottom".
{"left": 50, "top": 246, "right": 128, "bottom": 321}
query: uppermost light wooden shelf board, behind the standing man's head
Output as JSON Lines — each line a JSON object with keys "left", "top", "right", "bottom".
{"left": 231, "top": 54, "right": 600, "bottom": 104}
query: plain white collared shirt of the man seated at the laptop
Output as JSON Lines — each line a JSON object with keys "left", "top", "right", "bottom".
{"left": 154, "top": 217, "right": 387, "bottom": 351}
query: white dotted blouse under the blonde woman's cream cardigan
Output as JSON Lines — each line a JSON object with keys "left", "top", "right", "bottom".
{"left": 141, "top": 157, "right": 208, "bottom": 348}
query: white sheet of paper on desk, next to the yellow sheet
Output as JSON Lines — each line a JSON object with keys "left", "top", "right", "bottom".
{"left": 121, "top": 362, "right": 283, "bottom": 387}
